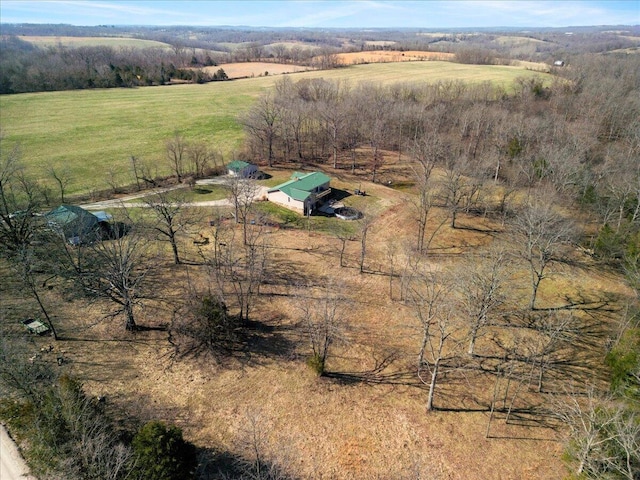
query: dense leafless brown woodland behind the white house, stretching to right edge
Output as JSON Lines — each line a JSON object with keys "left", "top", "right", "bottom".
{"left": 241, "top": 52, "right": 640, "bottom": 258}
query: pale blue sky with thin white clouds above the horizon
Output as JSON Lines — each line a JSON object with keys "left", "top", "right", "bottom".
{"left": 0, "top": 0, "right": 640, "bottom": 29}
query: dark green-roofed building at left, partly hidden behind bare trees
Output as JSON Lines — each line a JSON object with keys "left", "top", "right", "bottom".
{"left": 45, "top": 205, "right": 111, "bottom": 245}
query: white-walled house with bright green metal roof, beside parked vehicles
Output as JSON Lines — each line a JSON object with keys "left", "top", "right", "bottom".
{"left": 267, "top": 172, "right": 331, "bottom": 215}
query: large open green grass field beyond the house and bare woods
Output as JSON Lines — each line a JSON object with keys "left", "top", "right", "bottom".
{"left": 0, "top": 62, "right": 551, "bottom": 194}
